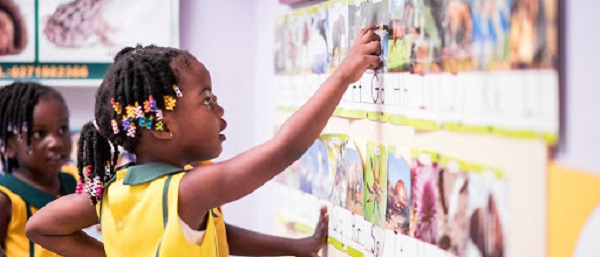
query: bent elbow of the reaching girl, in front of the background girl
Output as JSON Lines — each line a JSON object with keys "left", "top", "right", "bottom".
{"left": 25, "top": 194, "right": 106, "bottom": 257}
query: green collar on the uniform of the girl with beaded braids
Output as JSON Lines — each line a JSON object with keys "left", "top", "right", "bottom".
{"left": 123, "top": 162, "right": 183, "bottom": 186}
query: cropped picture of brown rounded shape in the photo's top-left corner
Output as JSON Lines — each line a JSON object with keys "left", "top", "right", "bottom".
{"left": 0, "top": 0, "right": 35, "bottom": 62}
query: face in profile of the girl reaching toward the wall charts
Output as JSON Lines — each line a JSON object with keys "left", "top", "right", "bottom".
{"left": 168, "top": 58, "right": 227, "bottom": 161}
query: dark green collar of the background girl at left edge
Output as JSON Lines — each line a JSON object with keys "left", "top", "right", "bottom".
{"left": 0, "top": 172, "right": 76, "bottom": 210}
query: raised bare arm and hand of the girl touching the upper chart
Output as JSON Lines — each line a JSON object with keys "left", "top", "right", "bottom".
{"left": 179, "top": 26, "right": 381, "bottom": 225}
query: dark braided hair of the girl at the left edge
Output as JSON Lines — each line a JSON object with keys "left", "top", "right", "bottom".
{"left": 0, "top": 82, "right": 65, "bottom": 173}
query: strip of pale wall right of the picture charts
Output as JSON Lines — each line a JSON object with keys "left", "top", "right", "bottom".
{"left": 557, "top": 0, "right": 600, "bottom": 173}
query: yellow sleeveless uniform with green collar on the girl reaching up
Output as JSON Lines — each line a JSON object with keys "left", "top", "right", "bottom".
{"left": 97, "top": 163, "right": 229, "bottom": 257}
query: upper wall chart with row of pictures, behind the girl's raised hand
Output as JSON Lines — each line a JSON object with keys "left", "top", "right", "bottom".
{"left": 274, "top": 0, "right": 559, "bottom": 144}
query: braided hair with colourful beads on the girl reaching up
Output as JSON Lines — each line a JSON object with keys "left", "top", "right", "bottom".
{"left": 77, "top": 45, "right": 194, "bottom": 205}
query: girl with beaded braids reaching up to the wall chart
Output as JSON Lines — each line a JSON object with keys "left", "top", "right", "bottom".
{"left": 27, "top": 26, "right": 380, "bottom": 257}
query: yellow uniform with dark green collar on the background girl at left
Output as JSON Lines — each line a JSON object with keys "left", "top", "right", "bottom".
{"left": 0, "top": 173, "right": 76, "bottom": 257}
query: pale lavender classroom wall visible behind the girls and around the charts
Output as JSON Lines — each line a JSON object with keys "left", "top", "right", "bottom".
{"left": 52, "top": 0, "right": 600, "bottom": 238}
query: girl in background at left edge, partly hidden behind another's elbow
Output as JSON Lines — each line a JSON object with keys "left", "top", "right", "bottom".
{"left": 0, "top": 82, "right": 76, "bottom": 257}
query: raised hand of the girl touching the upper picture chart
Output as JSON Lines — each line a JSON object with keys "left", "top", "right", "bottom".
{"left": 333, "top": 26, "right": 381, "bottom": 85}
